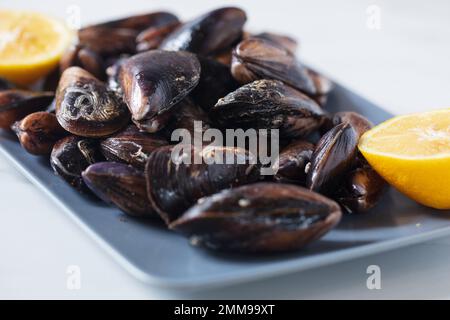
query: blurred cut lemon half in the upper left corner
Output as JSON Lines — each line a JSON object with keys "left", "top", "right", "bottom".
{"left": 0, "top": 10, "right": 74, "bottom": 86}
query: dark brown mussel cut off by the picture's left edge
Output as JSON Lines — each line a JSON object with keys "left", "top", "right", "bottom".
{"left": 0, "top": 89, "right": 54, "bottom": 129}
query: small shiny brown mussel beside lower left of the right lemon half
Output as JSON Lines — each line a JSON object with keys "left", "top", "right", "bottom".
{"left": 333, "top": 165, "right": 387, "bottom": 213}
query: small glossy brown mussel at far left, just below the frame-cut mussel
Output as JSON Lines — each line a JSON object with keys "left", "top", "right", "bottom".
{"left": 12, "top": 111, "right": 67, "bottom": 155}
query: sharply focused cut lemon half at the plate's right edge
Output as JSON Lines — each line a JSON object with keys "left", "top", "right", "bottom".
{"left": 359, "top": 108, "right": 450, "bottom": 209}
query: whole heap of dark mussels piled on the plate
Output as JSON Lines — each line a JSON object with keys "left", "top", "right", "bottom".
{"left": 0, "top": 7, "right": 385, "bottom": 252}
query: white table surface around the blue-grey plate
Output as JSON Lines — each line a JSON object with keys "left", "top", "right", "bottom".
{"left": 0, "top": 0, "right": 450, "bottom": 299}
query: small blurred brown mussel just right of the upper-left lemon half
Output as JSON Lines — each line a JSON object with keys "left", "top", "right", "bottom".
{"left": 59, "top": 44, "right": 105, "bottom": 80}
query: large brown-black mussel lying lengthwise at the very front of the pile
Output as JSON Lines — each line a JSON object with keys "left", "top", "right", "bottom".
{"left": 170, "top": 183, "right": 342, "bottom": 253}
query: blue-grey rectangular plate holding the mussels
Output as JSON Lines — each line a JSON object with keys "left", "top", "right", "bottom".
{"left": 0, "top": 86, "right": 450, "bottom": 288}
